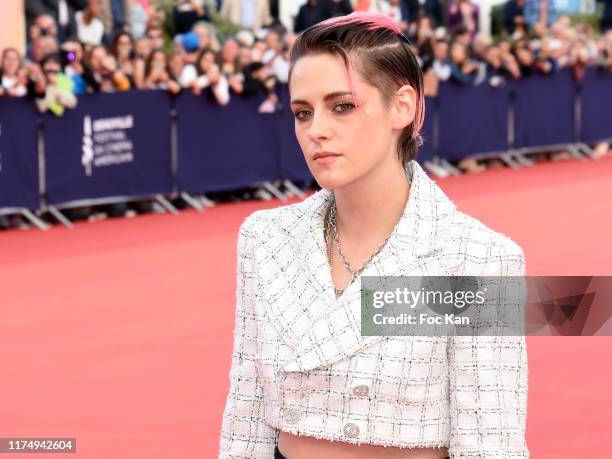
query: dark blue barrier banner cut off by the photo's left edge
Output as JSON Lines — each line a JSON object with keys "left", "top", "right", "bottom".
{"left": 0, "top": 97, "right": 39, "bottom": 209}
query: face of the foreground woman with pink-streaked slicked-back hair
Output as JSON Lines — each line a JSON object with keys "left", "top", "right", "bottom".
{"left": 290, "top": 54, "right": 408, "bottom": 189}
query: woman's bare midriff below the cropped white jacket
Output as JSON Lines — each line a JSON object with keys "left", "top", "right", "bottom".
{"left": 278, "top": 431, "right": 448, "bottom": 459}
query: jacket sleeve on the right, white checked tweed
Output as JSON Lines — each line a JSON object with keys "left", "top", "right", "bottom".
{"left": 447, "top": 242, "right": 529, "bottom": 459}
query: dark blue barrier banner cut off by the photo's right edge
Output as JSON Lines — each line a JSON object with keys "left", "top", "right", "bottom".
{"left": 580, "top": 68, "right": 612, "bottom": 142}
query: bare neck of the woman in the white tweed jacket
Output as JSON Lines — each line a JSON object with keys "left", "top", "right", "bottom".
{"left": 334, "top": 161, "right": 411, "bottom": 241}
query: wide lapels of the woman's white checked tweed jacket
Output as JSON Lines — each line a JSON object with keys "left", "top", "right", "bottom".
{"left": 251, "top": 161, "right": 456, "bottom": 371}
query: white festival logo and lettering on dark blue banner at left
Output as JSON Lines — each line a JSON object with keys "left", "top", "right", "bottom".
{"left": 81, "top": 115, "right": 134, "bottom": 176}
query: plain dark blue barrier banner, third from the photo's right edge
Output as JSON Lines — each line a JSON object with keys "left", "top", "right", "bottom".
{"left": 438, "top": 78, "right": 509, "bottom": 161}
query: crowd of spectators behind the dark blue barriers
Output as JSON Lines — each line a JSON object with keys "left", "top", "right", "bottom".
{"left": 0, "top": 0, "right": 612, "bottom": 226}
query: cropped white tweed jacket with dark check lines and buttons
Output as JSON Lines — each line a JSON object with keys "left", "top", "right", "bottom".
{"left": 219, "top": 161, "right": 529, "bottom": 459}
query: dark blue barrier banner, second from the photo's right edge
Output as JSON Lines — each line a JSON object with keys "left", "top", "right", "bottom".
{"left": 512, "top": 70, "right": 575, "bottom": 148}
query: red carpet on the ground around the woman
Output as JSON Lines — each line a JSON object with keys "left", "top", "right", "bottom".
{"left": 0, "top": 157, "right": 612, "bottom": 459}
